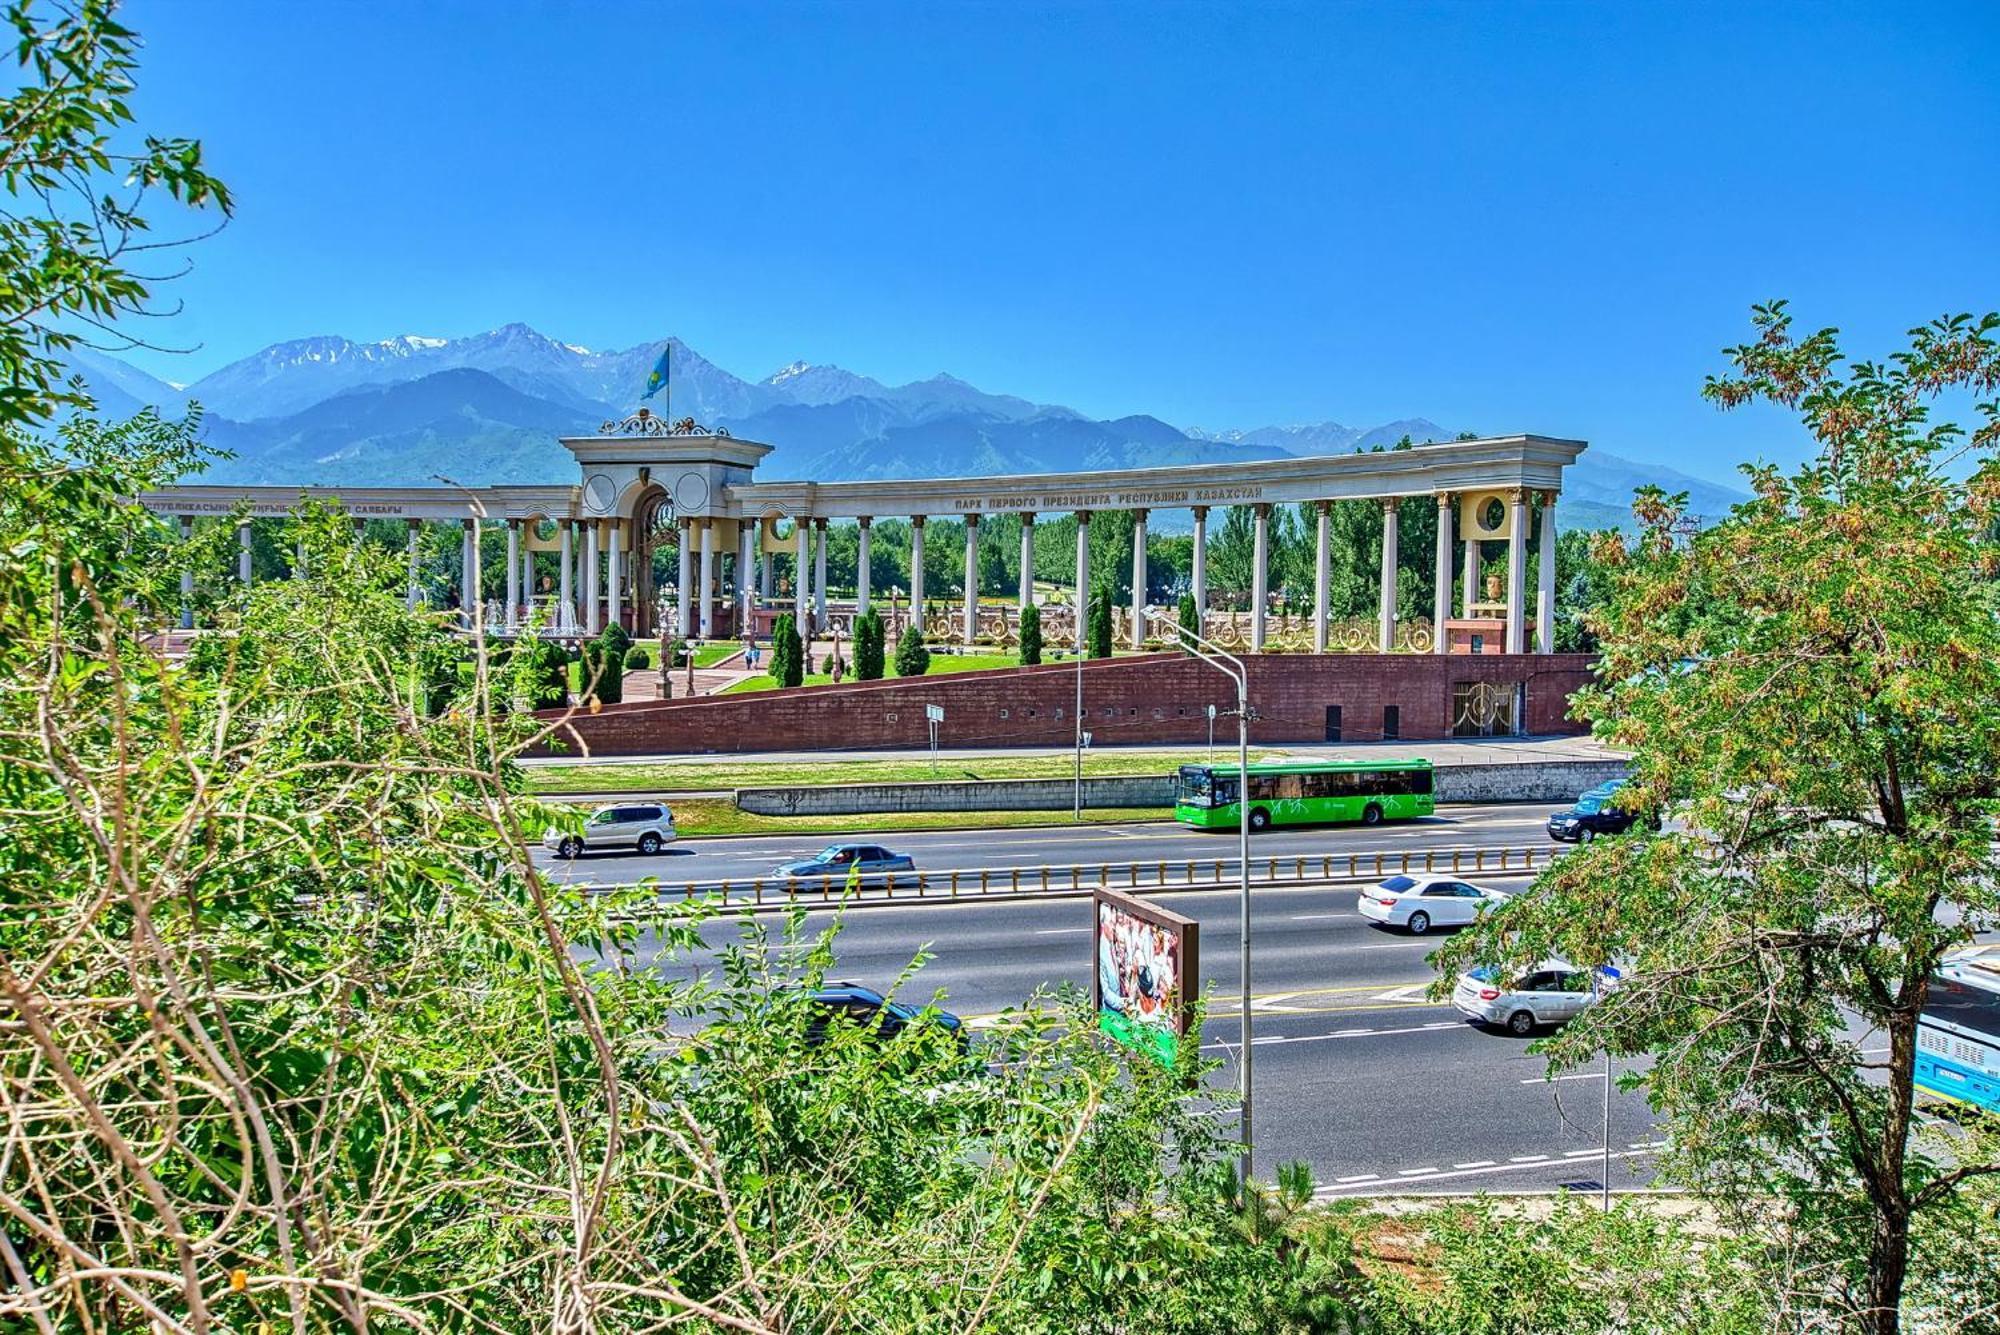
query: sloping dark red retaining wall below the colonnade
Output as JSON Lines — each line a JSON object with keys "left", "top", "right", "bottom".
{"left": 532, "top": 654, "right": 1592, "bottom": 755}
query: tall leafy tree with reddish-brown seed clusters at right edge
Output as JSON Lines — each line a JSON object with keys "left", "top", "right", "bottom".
{"left": 1442, "top": 304, "right": 2000, "bottom": 1335}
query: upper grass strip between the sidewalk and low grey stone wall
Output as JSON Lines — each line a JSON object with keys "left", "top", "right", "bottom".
{"left": 528, "top": 747, "right": 1282, "bottom": 795}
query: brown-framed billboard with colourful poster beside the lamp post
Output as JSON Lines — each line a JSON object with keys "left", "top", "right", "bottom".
{"left": 1090, "top": 889, "right": 1202, "bottom": 1067}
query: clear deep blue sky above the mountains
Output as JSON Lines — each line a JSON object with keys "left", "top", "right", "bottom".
{"left": 126, "top": 0, "right": 2000, "bottom": 478}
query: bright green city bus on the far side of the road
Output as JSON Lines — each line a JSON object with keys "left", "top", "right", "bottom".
{"left": 1174, "top": 759, "right": 1436, "bottom": 829}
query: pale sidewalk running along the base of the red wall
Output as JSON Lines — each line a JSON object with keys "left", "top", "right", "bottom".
{"left": 522, "top": 735, "right": 1626, "bottom": 767}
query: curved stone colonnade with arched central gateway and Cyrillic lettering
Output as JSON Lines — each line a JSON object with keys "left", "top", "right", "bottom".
{"left": 140, "top": 410, "right": 1584, "bottom": 749}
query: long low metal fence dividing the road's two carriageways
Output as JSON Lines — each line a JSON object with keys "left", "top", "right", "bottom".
{"left": 584, "top": 843, "right": 1568, "bottom": 909}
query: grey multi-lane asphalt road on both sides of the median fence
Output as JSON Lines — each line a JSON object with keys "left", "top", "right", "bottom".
{"left": 556, "top": 807, "right": 1654, "bottom": 1195}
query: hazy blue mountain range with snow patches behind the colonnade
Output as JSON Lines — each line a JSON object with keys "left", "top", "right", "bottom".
{"left": 58, "top": 324, "right": 1740, "bottom": 524}
